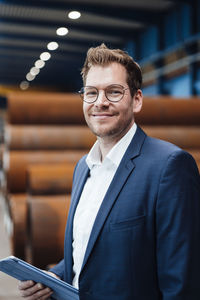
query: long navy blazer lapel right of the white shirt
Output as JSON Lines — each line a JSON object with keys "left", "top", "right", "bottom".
{"left": 81, "top": 127, "right": 146, "bottom": 271}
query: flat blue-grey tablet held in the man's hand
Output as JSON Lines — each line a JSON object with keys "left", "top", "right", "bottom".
{"left": 0, "top": 256, "right": 79, "bottom": 300}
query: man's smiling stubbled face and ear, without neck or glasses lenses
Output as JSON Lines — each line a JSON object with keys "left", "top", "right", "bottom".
{"left": 83, "top": 63, "right": 142, "bottom": 142}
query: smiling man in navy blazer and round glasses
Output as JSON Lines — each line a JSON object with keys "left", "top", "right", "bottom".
{"left": 19, "top": 44, "right": 200, "bottom": 300}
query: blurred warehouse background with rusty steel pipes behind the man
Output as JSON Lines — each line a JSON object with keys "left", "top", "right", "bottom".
{"left": 0, "top": 0, "right": 200, "bottom": 300}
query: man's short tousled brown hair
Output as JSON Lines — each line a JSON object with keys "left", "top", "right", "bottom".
{"left": 81, "top": 44, "right": 142, "bottom": 95}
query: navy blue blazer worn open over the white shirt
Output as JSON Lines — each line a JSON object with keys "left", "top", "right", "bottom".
{"left": 51, "top": 127, "right": 200, "bottom": 300}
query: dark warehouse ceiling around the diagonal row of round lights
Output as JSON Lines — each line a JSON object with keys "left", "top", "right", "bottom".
{"left": 0, "top": 0, "right": 189, "bottom": 91}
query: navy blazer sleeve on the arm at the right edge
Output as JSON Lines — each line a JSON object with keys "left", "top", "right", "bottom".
{"left": 156, "top": 150, "right": 200, "bottom": 300}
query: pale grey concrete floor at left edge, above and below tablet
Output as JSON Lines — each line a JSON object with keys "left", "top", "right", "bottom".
{"left": 0, "top": 195, "right": 22, "bottom": 300}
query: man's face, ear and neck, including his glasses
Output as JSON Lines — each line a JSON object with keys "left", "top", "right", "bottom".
{"left": 81, "top": 62, "right": 142, "bottom": 156}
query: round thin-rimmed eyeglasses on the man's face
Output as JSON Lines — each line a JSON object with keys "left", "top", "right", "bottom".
{"left": 78, "top": 84, "right": 129, "bottom": 103}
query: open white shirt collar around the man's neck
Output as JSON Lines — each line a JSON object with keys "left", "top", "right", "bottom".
{"left": 86, "top": 123, "right": 137, "bottom": 170}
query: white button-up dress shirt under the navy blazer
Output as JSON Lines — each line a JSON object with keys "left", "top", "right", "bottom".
{"left": 72, "top": 123, "right": 137, "bottom": 288}
